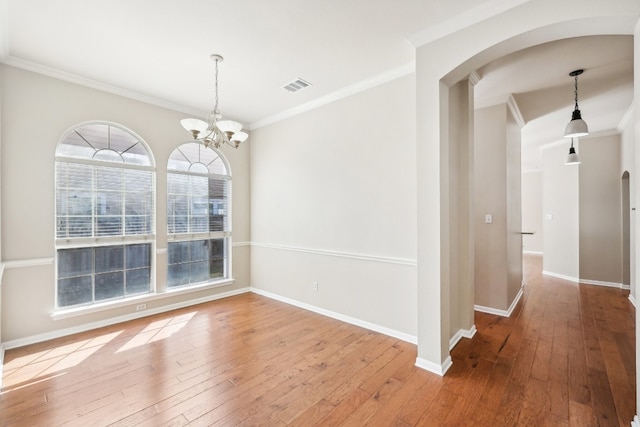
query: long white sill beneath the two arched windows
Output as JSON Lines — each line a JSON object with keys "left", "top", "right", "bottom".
{"left": 51, "top": 279, "right": 234, "bottom": 320}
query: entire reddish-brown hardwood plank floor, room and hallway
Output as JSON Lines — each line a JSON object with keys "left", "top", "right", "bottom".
{"left": 0, "top": 257, "right": 636, "bottom": 427}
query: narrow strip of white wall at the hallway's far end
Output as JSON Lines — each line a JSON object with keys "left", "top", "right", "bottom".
{"left": 522, "top": 171, "right": 544, "bottom": 255}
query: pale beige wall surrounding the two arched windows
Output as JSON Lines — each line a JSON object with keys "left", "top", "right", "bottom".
{"left": 0, "top": 66, "right": 250, "bottom": 345}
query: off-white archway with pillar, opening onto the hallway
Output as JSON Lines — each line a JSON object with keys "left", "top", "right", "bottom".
{"left": 412, "top": 1, "right": 638, "bottom": 384}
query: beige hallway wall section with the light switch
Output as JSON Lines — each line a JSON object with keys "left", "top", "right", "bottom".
{"left": 475, "top": 104, "right": 522, "bottom": 311}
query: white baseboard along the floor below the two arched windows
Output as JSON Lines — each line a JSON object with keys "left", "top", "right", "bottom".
{"left": 2, "top": 288, "right": 250, "bottom": 350}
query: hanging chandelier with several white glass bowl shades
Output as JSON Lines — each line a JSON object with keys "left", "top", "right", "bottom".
{"left": 180, "top": 53, "right": 249, "bottom": 148}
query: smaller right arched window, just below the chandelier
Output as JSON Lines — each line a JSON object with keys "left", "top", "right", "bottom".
{"left": 167, "top": 142, "right": 231, "bottom": 288}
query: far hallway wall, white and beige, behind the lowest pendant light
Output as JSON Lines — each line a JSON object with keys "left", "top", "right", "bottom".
{"left": 543, "top": 135, "right": 623, "bottom": 286}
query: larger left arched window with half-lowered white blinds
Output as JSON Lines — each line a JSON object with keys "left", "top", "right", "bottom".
{"left": 55, "top": 123, "right": 155, "bottom": 308}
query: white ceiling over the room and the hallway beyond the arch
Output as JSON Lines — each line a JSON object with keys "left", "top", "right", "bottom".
{"left": 0, "top": 0, "right": 633, "bottom": 169}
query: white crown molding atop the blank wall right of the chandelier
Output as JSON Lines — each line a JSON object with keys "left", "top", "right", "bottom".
{"left": 249, "top": 62, "right": 416, "bottom": 130}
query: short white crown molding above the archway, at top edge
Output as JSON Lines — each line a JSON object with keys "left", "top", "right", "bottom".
{"left": 409, "top": 0, "right": 529, "bottom": 48}
